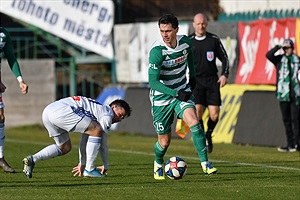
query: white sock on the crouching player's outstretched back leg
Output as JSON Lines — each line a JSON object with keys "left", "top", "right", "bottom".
{"left": 32, "top": 144, "right": 62, "bottom": 163}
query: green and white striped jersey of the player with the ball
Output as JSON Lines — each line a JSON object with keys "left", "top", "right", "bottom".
{"left": 148, "top": 35, "right": 195, "bottom": 106}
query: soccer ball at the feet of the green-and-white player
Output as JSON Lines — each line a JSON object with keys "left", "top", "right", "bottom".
{"left": 165, "top": 156, "right": 187, "bottom": 180}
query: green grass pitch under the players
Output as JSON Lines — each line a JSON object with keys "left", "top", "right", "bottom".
{"left": 0, "top": 126, "right": 300, "bottom": 200}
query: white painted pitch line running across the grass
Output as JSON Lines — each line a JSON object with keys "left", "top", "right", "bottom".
{"left": 6, "top": 139, "right": 300, "bottom": 171}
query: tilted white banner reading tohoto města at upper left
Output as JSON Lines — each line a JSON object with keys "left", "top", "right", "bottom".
{"left": 0, "top": 0, "right": 114, "bottom": 59}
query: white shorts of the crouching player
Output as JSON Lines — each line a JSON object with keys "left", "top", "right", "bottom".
{"left": 42, "top": 98, "right": 92, "bottom": 137}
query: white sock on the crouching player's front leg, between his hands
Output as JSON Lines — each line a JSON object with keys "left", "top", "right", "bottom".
{"left": 85, "top": 136, "right": 101, "bottom": 171}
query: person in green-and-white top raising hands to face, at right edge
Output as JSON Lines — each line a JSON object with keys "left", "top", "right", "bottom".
{"left": 266, "top": 39, "right": 300, "bottom": 152}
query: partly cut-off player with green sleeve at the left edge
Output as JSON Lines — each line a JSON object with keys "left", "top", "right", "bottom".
{"left": 0, "top": 27, "right": 28, "bottom": 173}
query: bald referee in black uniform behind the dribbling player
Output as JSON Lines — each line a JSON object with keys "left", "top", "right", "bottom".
{"left": 190, "top": 13, "right": 229, "bottom": 153}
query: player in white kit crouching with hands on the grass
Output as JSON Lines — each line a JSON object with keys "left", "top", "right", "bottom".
{"left": 23, "top": 96, "right": 131, "bottom": 178}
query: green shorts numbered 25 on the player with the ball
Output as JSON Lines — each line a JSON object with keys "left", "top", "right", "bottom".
{"left": 152, "top": 99, "right": 196, "bottom": 135}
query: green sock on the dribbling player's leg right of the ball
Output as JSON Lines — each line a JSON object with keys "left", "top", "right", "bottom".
{"left": 190, "top": 123, "right": 208, "bottom": 162}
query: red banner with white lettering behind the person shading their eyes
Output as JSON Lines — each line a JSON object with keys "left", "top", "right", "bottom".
{"left": 235, "top": 18, "right": 298, "bottom": 84}
